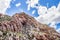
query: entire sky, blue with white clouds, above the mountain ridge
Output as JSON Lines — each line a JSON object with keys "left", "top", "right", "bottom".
{"left": 0, "top": 0, "right": 60, "bottom": 32}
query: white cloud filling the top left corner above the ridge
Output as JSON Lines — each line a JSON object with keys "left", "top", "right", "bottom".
{"left": 0, "top": 0, "right": 11, "bottom": 14}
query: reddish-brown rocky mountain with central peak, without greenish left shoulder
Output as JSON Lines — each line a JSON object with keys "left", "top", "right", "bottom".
{"left": 0, "top": 12, "right": 60, "bottom": 40}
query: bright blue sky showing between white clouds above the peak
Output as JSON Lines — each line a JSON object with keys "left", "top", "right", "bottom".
{"left": 6, "top": 0, "right": 60, "bottom": 16}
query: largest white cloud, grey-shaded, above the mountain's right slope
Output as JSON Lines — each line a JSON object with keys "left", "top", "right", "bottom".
{"left": 36, "top": 3, "right": 60, "bottom": 28}
